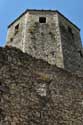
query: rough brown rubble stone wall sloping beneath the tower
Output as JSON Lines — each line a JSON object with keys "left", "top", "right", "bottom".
{"left": 0, "top": 47, "right": 83, "bottom": 125}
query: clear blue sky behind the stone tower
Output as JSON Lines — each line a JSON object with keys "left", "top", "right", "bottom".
{"left": 0, "top": 0, "right": 83, "bottom": 46}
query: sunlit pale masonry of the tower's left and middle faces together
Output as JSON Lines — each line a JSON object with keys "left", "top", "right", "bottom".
{"left": 7, "top": 11, "right": 64, "bottom": 67}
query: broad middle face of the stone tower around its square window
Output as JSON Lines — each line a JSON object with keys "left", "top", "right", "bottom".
{"left": 25, "top": 11, "right": 64, "bottom": 67}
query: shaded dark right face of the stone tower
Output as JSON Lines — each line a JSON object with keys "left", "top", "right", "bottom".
{"left": 58, "top": 15, "right": 83, "bottom": 71}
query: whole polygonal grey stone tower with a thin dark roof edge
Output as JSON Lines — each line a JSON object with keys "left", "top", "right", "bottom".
{"left": 7, "top": 10, "right": 83, "bottom": 71}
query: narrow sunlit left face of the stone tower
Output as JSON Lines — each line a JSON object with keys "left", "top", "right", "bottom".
{"left": 6, "top": 15, "right": 25, "bottom": 50}
